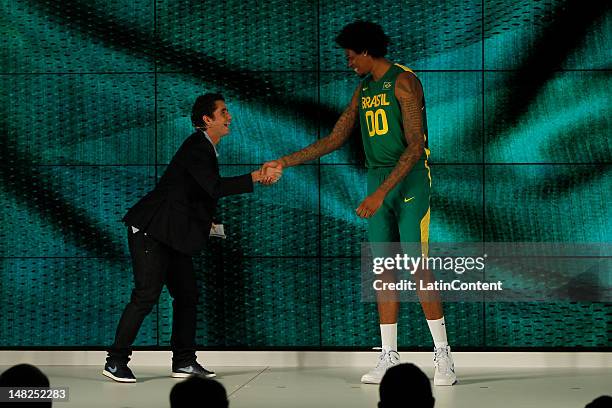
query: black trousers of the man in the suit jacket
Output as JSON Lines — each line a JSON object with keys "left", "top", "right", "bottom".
{"left": 108, "top": 227, "right": 198, "bottom": 365}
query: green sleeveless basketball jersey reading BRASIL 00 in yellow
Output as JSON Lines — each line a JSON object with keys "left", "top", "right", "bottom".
{"left": 359, "top": 64, "right": 429, "bottom": 169}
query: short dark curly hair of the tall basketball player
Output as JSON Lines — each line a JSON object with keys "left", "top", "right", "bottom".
{"left": 336, "top": 21, "right": 391, "bottom": 58}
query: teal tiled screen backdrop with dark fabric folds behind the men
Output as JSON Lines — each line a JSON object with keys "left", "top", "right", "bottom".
{"left": 0, "top": 0, "right": 612, "bottom": 350}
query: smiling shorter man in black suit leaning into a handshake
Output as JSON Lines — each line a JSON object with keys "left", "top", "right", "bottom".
{"left": 102, "top": 94, "right": 280, "bottom": 382}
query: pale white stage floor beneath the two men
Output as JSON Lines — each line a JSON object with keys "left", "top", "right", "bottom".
{"left": 0, "top": 365, "right": 612, "bottom": 408}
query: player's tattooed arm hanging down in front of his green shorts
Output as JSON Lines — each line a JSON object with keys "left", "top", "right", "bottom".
{"left": 357, "top": 72, "right": 425, "bottom": 218}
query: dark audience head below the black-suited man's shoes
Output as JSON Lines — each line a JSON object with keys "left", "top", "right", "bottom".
{"left": 170, "top": 376, "right": 229, "bottom": 408}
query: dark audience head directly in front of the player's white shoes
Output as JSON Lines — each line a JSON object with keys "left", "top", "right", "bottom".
{"left": 378, "top": 364, "right": 435, "bottom": 408}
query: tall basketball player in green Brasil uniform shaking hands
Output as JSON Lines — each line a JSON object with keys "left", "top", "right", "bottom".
{"left": 264, "top": 21, "right": 457, "bottom": 385}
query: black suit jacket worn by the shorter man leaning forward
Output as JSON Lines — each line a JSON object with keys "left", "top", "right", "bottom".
{"left": 123, "top": 132, "right": 253, "bottom": 255}
